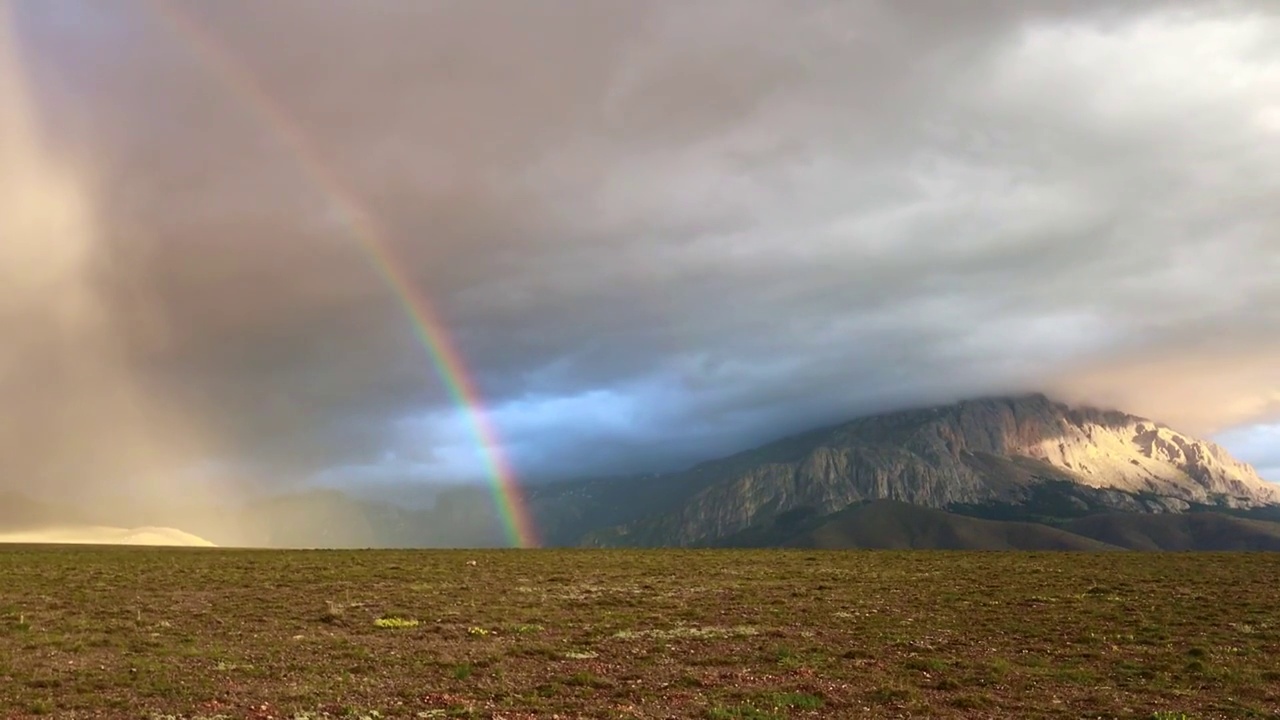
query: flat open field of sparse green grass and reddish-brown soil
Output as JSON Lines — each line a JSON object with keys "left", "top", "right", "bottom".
{"left": 0, "top": 546, "right": 1280, "bottom": 720}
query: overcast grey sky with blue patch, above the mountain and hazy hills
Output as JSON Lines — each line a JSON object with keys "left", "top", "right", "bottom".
{"left": 0, "top": 0, "right": 1280, "bottom": 499}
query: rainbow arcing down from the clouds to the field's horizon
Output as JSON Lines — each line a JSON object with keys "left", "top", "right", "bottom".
{"left": 151, "top": 0, "right": 538, "bottom": 547}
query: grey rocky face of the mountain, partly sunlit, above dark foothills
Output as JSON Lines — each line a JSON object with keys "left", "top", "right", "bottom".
{"left": 588, "top": 395, "right": 1280, "bottom": 544}
